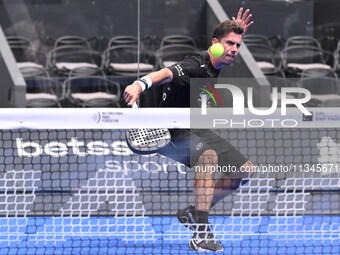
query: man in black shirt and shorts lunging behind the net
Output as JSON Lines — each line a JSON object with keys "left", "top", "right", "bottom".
{"left": 124, "top": 8, "right": 253, "bottom": 251}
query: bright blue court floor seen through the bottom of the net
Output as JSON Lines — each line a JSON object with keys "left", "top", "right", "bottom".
{"left": 0, "top": 216, "right": 340, "bottom": 255}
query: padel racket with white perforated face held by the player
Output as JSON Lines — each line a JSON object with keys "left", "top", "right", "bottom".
{"left": 125, "top": 101, "right": 171, "bottom": 154}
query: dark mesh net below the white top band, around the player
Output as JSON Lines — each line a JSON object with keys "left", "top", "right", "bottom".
{"left": 0, "top": 128, "right": 340, "bottom": 254}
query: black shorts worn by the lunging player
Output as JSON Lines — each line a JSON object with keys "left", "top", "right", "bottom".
{"left": 157, "top": 129, "right": 248, "bottom": 173}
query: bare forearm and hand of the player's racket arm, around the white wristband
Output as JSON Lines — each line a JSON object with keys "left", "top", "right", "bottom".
{"left": 124, "top": 68, "right": 173, "bottom": 106}
